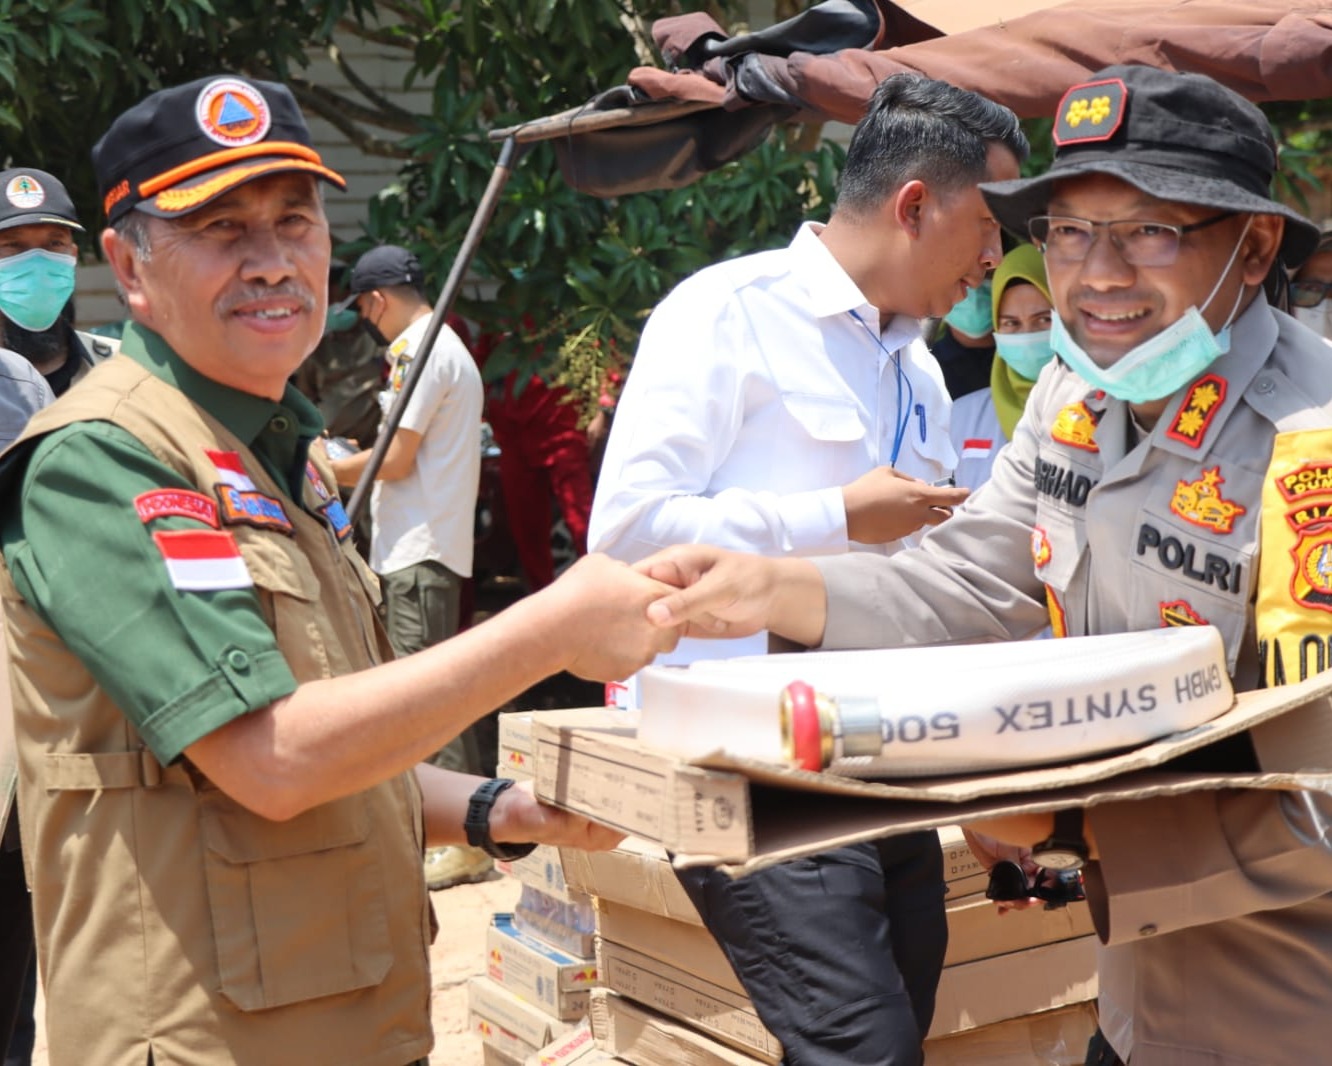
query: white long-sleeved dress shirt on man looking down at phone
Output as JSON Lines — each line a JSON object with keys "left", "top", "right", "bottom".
{"left": 589, "top": 223, "right": 956, "bottom": 561}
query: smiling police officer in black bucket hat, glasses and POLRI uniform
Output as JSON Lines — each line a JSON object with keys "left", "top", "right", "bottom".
{"left": 642, "top": 67, "right": 1332, "bottom": 1066}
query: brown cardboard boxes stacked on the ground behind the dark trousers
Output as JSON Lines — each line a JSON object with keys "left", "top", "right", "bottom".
{"left": 472, "top": 713, "right": 1096, "bottom": 1066}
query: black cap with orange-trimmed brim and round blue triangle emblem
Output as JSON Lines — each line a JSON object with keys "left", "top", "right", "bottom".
{"left": 92, "top": 75, "right": 346, "bottom": 223}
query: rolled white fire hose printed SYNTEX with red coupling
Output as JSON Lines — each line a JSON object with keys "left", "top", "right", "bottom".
{"left": 638, "top": 626, "right": 1235, "bottom": 777}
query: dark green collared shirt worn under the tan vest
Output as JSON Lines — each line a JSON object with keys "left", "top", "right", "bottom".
{"left": 0, "top": 325, "right": 322, "bottom": 765}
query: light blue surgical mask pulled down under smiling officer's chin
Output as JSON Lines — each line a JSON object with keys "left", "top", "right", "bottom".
{"left": 1050, "top": 216, "right": 1253, "bottom": 404}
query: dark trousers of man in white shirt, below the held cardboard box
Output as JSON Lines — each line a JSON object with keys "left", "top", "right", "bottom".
{"left": 677, "top": 831, "right": 948, "bottom": 1066}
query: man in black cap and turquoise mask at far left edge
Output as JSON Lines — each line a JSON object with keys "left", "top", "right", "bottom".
{"left": 0, "top": 167, "right": 116, "bottom": 396}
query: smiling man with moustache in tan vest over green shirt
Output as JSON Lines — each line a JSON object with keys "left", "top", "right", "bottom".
{"left": 0, "top": 76, "right": 675, "bottom": 1066}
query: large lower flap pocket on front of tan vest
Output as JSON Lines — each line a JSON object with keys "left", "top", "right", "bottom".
{"left": 198, "top": 790, "right": 393, "bottom": 1010}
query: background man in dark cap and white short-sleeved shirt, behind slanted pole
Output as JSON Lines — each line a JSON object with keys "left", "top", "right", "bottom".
{"left": 333, "top": 244, "right": 494, "bottom": 889}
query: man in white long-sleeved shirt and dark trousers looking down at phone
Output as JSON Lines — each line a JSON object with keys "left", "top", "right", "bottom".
{"left": 589, "top": 75, "right": 1027, "bottom": 1066}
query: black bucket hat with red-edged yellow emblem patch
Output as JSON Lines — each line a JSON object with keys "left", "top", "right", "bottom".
{"left": 980, "top": 65, "right": 1319, "bottom": 267}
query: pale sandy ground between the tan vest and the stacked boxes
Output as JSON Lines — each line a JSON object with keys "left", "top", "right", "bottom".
{"left": 32, "top": 874, "right": 521, "bottom": 1066}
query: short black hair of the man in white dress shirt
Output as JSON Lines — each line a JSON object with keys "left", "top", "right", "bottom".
{"left": 838, "top": 73, "right": 1031, "bottom": 213}
